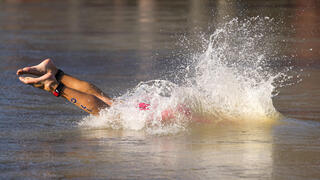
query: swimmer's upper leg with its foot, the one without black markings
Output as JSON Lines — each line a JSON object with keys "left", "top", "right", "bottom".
{"left": 17, "top": 59, "right": 112, "bottom": 106}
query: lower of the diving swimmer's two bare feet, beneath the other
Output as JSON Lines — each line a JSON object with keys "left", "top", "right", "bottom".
{"left": 19, "top": 73, "right": 58, "bottom": 92}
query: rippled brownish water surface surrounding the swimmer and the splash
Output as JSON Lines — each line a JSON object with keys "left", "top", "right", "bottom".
{"left": 0, "top": 0, "right": 320, "bottom": 179}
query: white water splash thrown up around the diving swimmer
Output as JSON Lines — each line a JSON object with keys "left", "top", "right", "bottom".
{"left": 80, "top": 17, "right": 287, "bottom": 134}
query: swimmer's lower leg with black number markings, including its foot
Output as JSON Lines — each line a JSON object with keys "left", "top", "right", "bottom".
{"left": 19, "top": 74, "right": 108, "bottom": 115}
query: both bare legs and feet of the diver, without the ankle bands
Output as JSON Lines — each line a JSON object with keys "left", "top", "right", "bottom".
{"left": 17, "top": 59, "right": 112, "bottom": 115}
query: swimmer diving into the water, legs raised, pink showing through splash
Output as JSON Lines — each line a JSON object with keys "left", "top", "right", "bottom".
{"left": 17, "top": 59, "right": 190, "bottom": 123}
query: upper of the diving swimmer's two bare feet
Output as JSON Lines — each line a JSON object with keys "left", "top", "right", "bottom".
{"left": 17, "top": 59, "right": 58, "bottom": 76}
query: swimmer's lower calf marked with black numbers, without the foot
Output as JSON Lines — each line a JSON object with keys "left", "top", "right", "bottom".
{"left": 53, "top": 85, "right": 108, "bottom": 115}
